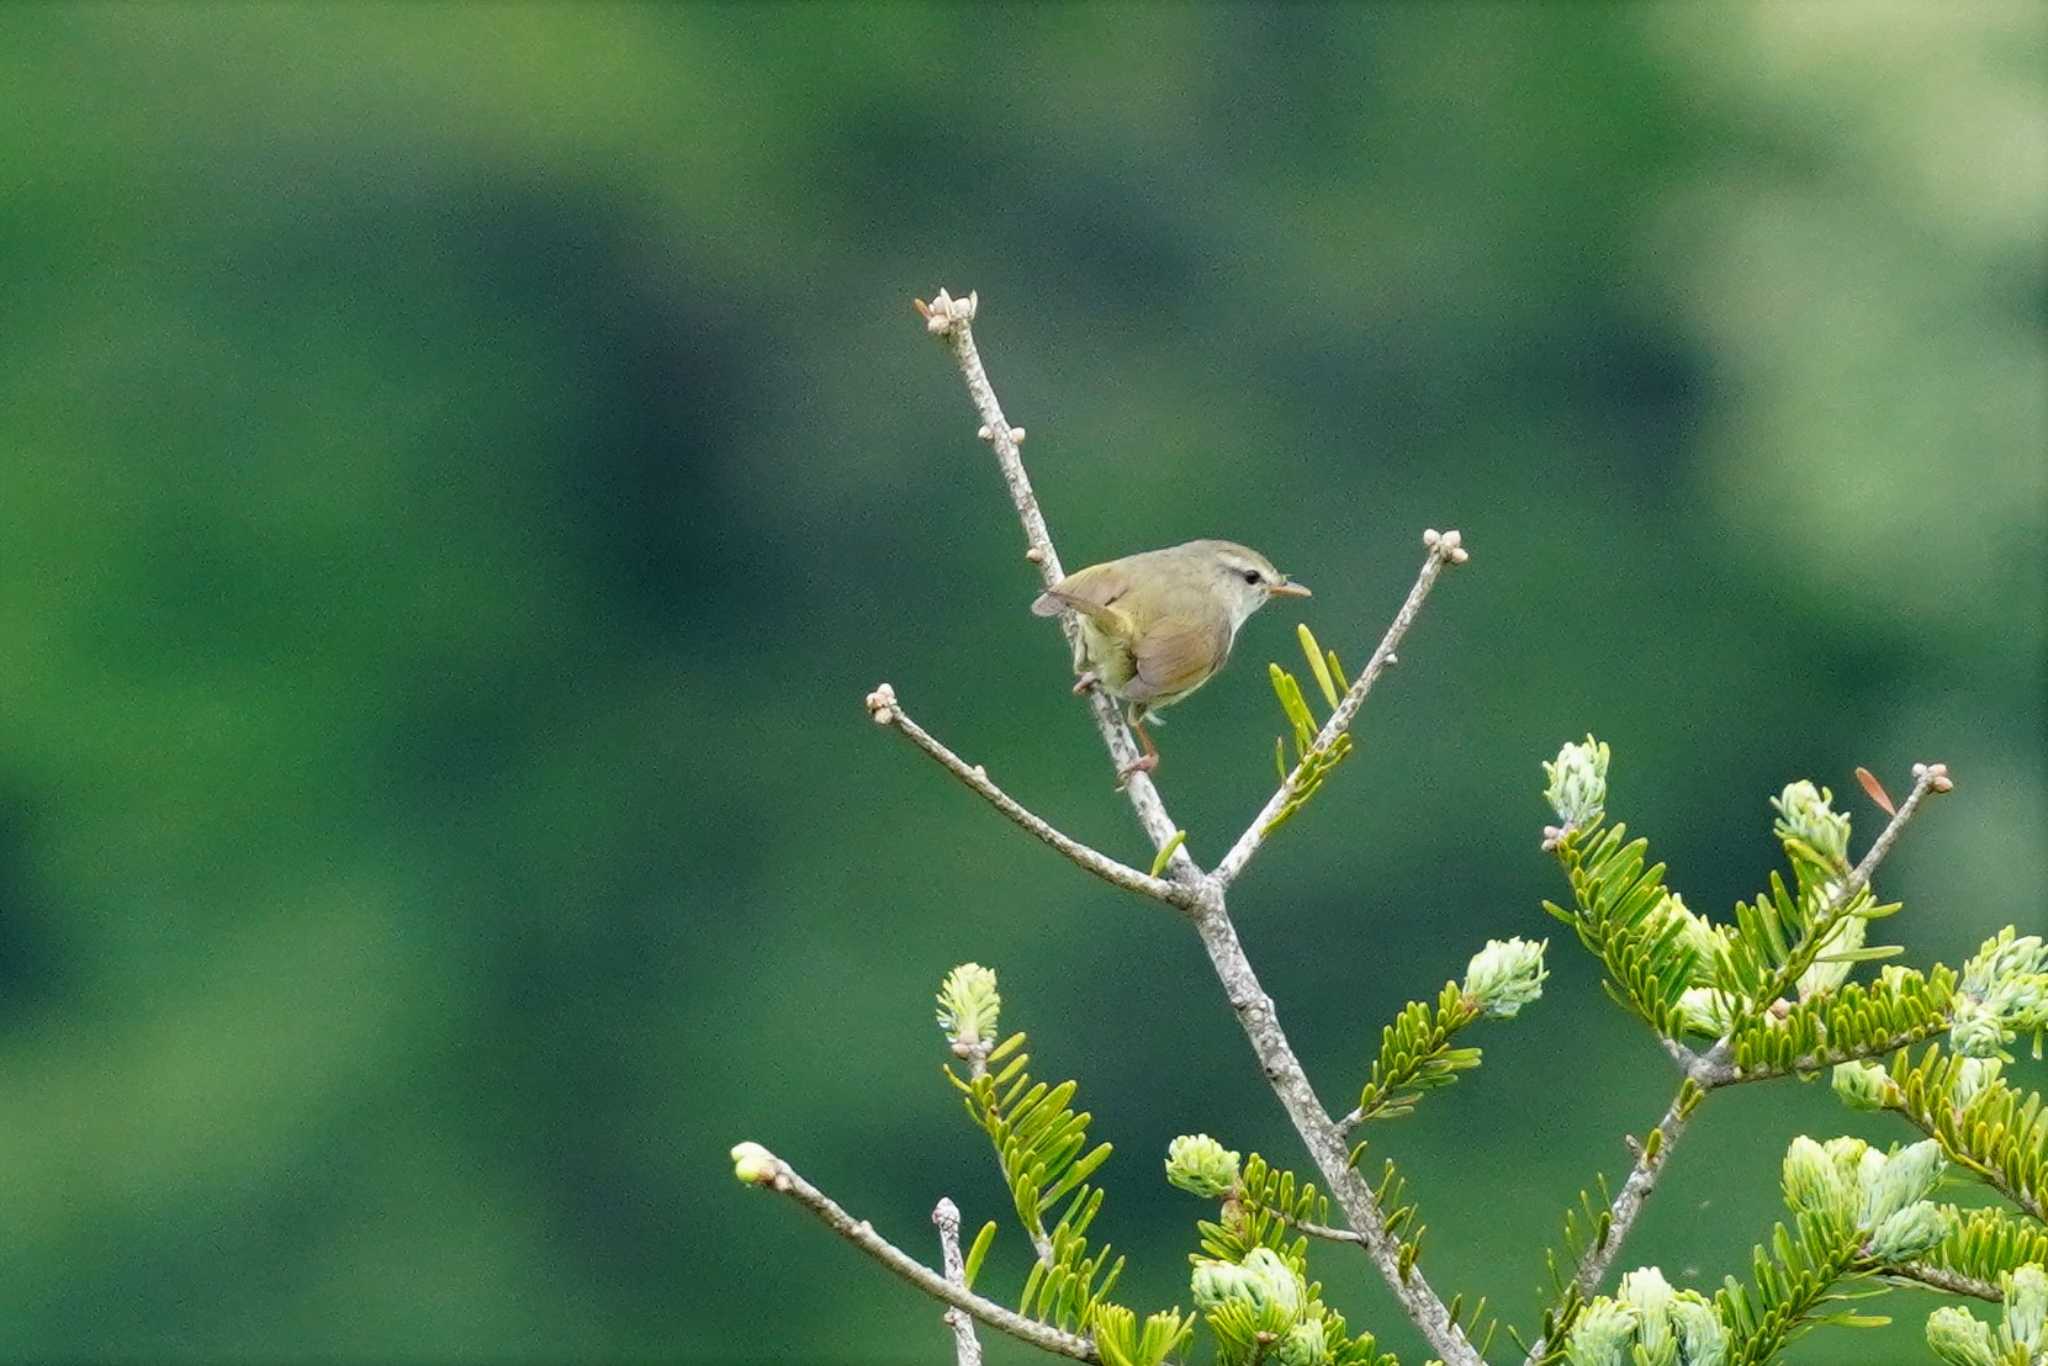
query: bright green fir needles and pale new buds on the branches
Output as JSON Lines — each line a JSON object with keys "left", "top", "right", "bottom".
{"left": 735, "top": 610, "right": 2048, "bottom": 1366}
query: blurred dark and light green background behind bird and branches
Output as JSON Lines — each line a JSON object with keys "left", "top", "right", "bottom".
{"left": 0, "top": 0, "right": 2048, "bottom": 1362}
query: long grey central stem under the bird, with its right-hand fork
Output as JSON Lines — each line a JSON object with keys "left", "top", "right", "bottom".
{"left": 918, "top": 291, "right": 1485, "bottom": 1366}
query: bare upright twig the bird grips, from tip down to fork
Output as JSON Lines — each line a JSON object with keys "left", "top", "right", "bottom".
{"left": 918, "top": 289, "right": 1202, "bottom": 885}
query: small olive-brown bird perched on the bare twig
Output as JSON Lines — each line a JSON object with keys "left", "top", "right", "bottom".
{"left": 1030, "top": 541, "right": 1309, "bottom": 778}
